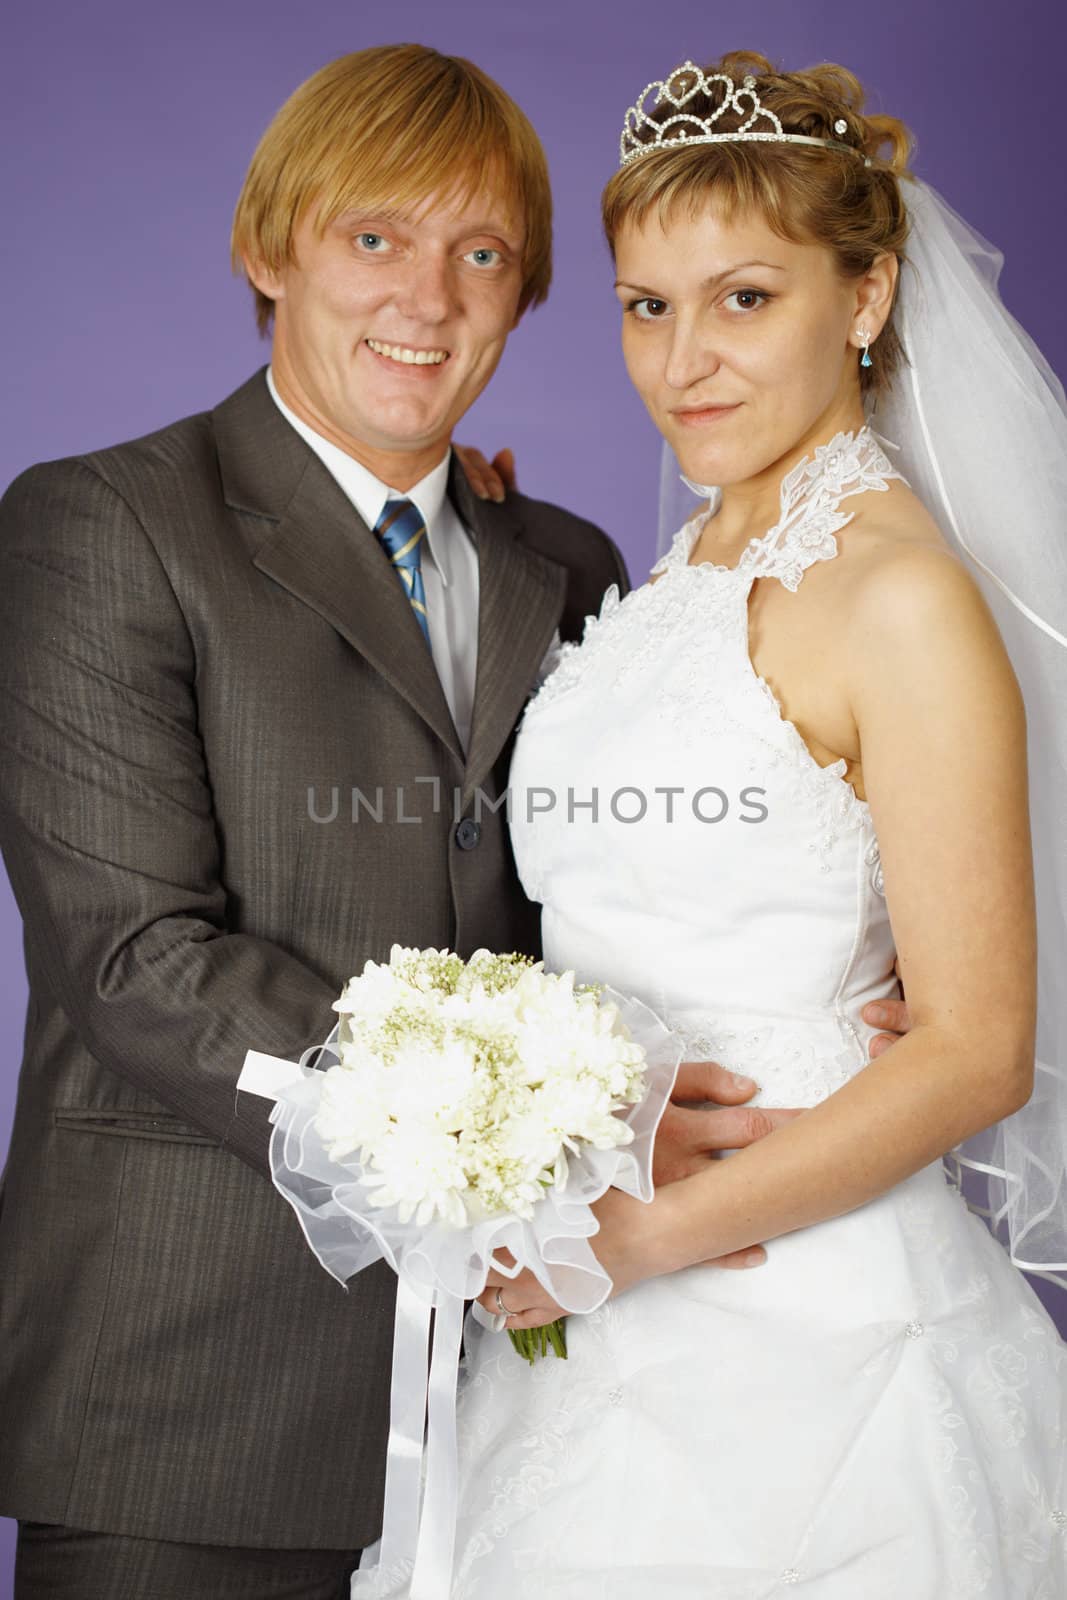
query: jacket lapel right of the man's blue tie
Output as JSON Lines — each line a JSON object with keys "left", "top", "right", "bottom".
{"left": 450, "top": 458, "right": 566, "bottom": 806}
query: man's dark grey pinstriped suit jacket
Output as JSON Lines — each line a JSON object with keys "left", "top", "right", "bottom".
{"left": 0, "top": 373, "right": 625, "bottom": 1547}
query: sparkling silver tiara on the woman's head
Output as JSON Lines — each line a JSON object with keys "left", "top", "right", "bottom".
{"left": 619, "top": 61, "right": 872, "bottom": 166}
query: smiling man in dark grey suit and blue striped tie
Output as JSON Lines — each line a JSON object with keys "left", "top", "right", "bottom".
{"left": 0, "top": 45, "right": 908, "bottom": 1600}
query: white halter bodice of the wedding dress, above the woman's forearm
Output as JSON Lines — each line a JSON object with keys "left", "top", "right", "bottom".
{"left": 512, "top": 429, "right": 899, "bottom": 1104}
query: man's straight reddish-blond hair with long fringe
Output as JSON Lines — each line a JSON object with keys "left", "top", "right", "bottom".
{"left": 230, "top": 45, "right": 552, "bottom": 333}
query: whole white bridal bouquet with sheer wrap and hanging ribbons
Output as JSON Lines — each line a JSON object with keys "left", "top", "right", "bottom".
{"left": 238, "top": 946, "right": 681, "bottom": 1595}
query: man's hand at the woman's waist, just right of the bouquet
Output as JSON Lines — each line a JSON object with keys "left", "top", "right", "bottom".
{"left": 653, "top": 1061, "right": 803, "bottom": 1267}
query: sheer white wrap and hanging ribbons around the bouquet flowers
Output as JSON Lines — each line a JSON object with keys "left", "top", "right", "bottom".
{"left": 237, "top": 989, "right": 683, "bottom": 1600}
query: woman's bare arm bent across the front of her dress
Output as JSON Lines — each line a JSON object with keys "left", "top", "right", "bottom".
{"left": 639, "top": 546, "right": 1035, "bottom": 1275}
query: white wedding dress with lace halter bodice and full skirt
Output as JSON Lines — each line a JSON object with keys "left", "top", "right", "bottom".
{"left": 441, "top": 429, "right": 1067, "bottom": 1600}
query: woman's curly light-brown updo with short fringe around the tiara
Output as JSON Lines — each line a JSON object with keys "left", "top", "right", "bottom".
{"left": 603, "top": 50, "right": 912, "bottom": 394}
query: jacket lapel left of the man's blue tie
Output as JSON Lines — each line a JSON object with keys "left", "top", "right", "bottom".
{"left": 213, "top": 373, "right": 464, "bottom": 763}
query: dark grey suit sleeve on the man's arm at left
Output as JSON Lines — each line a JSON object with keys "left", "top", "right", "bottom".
{"left": 0, "top": 461, "right": 336, "bottom": 1173}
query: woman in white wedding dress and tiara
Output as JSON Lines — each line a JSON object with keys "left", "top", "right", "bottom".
{"left": 435, "top": 56, "right": 1067, "bottom": 1600}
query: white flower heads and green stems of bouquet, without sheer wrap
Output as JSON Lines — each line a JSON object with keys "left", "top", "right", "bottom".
{"left": 315, "top": 944, "right": 645, "bottom": 1360}
